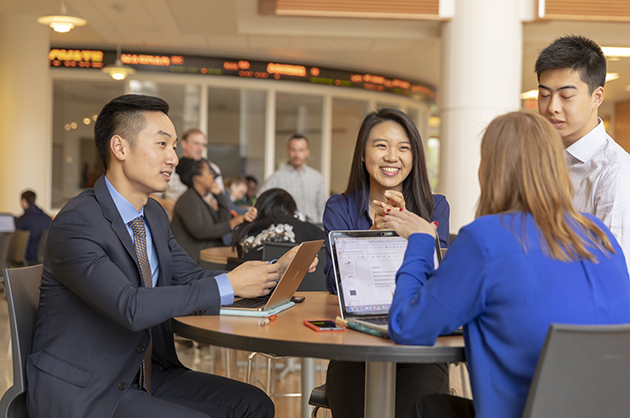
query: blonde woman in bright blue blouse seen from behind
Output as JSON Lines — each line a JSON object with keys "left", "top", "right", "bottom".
{"left": 384, "top": 112, "right": 630, "bottom": 418}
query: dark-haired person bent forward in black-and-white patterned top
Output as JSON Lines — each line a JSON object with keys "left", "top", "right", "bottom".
{"left": 232, "top": 189, "right": 325, "bottom": 260}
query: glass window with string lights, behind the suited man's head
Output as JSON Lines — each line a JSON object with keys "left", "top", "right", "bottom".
{"left": 51, "top": 80, "right": 124, "bottom": 209}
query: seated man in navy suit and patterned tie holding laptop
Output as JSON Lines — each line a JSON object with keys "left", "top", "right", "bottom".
{"left": 27, "top": 95, "right": 294, "bottom": 418}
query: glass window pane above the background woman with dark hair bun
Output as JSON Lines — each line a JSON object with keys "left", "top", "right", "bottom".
{"left": 207, "top": 87, "right": 267, "bottom": 184}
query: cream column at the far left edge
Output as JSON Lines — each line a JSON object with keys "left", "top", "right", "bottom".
{"left": 0, "top": 14, "right": 52, "bottom": 215}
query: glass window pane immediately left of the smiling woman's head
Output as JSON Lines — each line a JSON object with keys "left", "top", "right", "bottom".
{"left": 330, "top": 97, "right": 368, "bottom": 194}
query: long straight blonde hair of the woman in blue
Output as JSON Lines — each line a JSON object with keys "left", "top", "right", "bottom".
{"left": 477, "top": 112, "right": 614, "bottom": 261}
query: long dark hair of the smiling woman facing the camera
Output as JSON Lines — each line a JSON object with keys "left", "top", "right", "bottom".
{"left": 344, "top": 108, "right": 433, "bottom": 221}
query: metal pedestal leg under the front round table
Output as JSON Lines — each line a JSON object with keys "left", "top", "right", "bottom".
{"left": 365, "top": 361, "right": 396, "bottom": 418}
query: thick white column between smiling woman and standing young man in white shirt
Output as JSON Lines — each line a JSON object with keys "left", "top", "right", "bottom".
{"left": 439, "top": 0, "right": 523, "bottom": 233}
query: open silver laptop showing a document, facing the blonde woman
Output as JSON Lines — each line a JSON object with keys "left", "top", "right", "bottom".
{"left": 328, "top": 231, "right": 442, "bottom": 332}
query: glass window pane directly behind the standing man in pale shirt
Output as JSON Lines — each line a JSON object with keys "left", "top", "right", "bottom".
{"left": 274, "top": 93, "right": 324, "bottom": 171}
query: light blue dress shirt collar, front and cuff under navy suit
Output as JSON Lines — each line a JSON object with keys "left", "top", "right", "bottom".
{"left": 105, "top": 176, "right": 234, "bottom": 305}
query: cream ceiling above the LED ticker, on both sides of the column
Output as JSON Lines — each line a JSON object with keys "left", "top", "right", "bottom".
{"left": 0, "top": 0, "right": 630, "bottom": 102}
